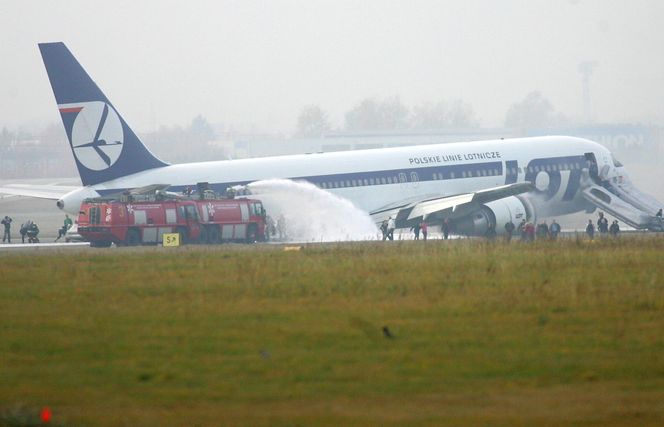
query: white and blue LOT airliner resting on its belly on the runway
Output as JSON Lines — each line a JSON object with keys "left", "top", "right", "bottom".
{"left": 0, "top": 43, "right": 662, "bottom": 235}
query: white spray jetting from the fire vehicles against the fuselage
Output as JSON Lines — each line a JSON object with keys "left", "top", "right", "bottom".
{"left": 248, "top": 179, "right": 378, "bottom": 242}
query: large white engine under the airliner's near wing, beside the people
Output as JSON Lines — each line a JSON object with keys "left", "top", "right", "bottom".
{"left": 452, "top": 196, "right": 536, "bottom": 236}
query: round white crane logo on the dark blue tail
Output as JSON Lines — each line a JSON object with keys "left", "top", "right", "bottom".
{"left": 67, "top": 101, "right": 124, "bottom": 171}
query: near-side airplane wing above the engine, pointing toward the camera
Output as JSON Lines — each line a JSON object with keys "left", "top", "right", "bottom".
{"left": 370, "top": 182, "right": 535, "bottom": 228}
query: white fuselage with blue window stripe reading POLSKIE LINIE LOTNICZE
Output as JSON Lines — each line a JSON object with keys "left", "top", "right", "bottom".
{"left": 59, "top": 136, "right": 612, "bottom": 221}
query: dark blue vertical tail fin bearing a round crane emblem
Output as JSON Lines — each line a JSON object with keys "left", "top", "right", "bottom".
{"left": 39, "top": 42, "right": 167, "bottom": 185}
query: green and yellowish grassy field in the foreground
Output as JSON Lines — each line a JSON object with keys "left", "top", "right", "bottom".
{"left": 0, "top": 237, "right": 664, "bottom": 426}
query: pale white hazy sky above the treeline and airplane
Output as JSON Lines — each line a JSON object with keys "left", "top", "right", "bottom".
{"left": 0, "top": 0, "right": 664, "bottom": 132}
